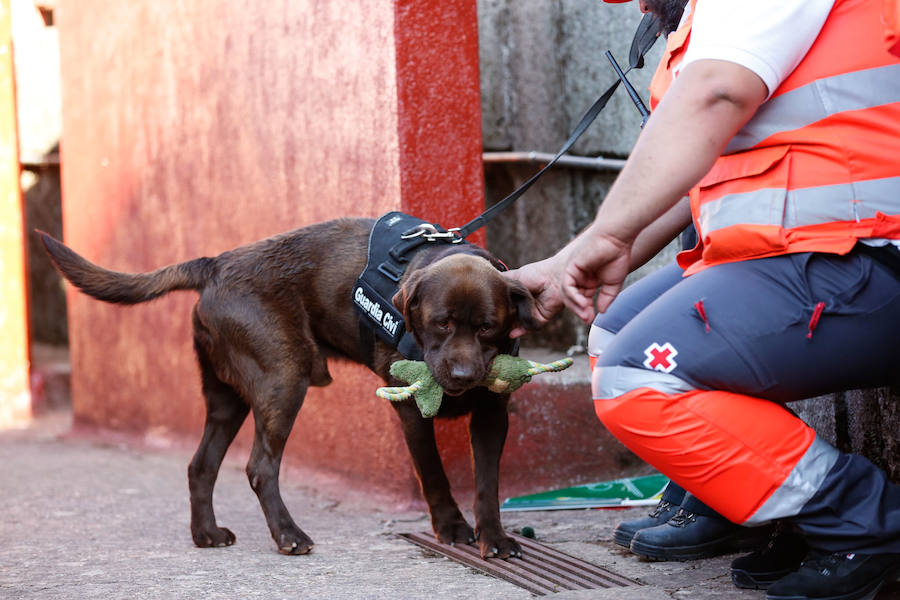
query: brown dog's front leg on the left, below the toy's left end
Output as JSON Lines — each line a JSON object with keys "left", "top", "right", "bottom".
{"left": 391, "top": 402, "right": 475, "bottom": 544}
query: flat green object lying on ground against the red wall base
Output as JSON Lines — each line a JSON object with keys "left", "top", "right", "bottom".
{"left": 500, "top": 474, "right": 669, "bottom": 512}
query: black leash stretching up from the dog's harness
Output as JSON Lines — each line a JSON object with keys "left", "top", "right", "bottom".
{"left": 451, "top": 13, "right": 659, "bottom": 240}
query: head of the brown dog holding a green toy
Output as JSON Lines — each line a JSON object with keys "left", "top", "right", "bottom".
{"left": 393, "top": 254, "right": 535, "bottom": 396}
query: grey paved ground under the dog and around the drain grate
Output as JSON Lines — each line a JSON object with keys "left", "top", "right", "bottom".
{"left": 0, "top": 414, "right": 900, "bottom": 600}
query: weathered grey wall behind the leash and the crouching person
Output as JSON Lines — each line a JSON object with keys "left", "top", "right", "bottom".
{"left": 478, "top": 0, "right": 900, "bottom": 481}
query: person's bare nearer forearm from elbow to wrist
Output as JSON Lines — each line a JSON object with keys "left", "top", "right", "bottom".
{"left": 589, "top": 60, "right": 767, "bottom": 245}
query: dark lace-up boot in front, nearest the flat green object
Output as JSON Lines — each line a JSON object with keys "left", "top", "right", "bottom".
{"left": 631, "top": 495, "right": 772, "bottom": 560}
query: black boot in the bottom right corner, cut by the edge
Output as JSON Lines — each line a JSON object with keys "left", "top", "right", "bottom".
{"left": 766, "top": 552, "right": 900, "bottom": 600}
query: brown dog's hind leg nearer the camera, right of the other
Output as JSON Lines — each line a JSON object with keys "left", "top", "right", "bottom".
{"left": 247, "top": 377, "right": 313, "bottom": 554}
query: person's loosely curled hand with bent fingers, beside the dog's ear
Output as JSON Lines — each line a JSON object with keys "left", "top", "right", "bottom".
{"left": 554, "top": 226, "right": 631, "bottom": 324}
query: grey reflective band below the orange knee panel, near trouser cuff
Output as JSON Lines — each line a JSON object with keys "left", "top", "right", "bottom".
{"left": 744, "top": 436, "right": 840, "bottom": 525}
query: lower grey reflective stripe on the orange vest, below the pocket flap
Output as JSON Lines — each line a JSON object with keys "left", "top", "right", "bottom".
{"left": 697, "top": 177, "right": 900, "bottom": 235}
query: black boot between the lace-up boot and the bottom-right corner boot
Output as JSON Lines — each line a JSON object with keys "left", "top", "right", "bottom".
{"left": 731, "top": 524, "right": 807, "bottom": 590}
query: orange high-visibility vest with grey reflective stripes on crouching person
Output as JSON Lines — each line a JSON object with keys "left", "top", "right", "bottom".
{"left": 650, "top": 0, "right": 900, "bottom": 275}
